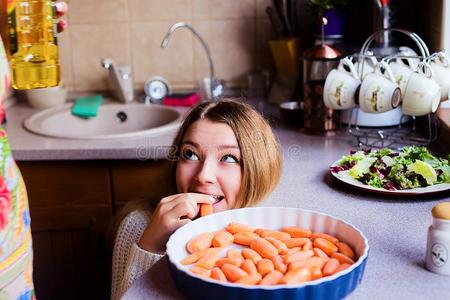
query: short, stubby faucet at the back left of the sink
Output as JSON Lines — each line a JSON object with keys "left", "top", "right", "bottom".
{"left": 101, "top": 58, "right": 134, "bottom": 103}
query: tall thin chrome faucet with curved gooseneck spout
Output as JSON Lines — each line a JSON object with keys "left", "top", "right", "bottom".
{"left": 161, "top": 22, "right": 224, "bottom": 100}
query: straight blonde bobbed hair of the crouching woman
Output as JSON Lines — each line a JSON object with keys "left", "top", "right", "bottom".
{"left": 169, "top": 99, "right": 281, "bottom": 208}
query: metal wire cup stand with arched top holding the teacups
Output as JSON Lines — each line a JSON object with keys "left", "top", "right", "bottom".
{"left": 347, "top": 28, "right": 438, "bottom": 149}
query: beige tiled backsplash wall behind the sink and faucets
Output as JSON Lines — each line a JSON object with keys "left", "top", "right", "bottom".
{"left": 59, "top": 0, "right": 273, "bottom": 91}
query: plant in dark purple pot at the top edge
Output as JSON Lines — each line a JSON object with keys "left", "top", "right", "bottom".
{"left": 308, "top": 0, "right": 357, "bottom": 38}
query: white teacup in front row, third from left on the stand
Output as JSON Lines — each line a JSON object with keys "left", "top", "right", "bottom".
{"left": 402, "top": 62, "right": 441, "bottom": 116}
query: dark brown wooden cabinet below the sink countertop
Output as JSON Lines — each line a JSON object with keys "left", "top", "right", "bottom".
{"left": 17, "top": 161, "right": 170, "bottom": 299}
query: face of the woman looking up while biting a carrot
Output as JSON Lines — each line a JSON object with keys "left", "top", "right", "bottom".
{"left": 175, "top": 120, "right": 242, "bottom": 212}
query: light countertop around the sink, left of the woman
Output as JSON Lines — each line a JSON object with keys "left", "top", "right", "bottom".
{"left": 4, "top": 102, "right": 187, "bottom": 161}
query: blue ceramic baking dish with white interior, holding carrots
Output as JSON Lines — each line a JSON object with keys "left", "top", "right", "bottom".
{"left": 167, "top": 207, "right": 369, "bottom": 300}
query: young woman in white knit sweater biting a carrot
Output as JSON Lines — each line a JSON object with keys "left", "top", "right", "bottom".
{"left": 111, "top": 100, "right": 281, "bottom": 299}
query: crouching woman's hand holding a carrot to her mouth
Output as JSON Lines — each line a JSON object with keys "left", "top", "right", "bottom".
{"left": 138, "top": 193, "right": 214, "bottom": 252}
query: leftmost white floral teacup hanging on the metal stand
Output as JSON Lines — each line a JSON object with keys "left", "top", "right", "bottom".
{"left": 323, "top": 57, "right": 361, "bottom": 109}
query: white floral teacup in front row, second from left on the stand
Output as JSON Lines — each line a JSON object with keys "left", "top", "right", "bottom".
{"left": 359, "top": 61, "right": 401, "bottom": 113}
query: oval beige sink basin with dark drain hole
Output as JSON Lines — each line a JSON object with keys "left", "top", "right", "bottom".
{"left": 24, "top": 103, "right": 181, "bottom": 139}
